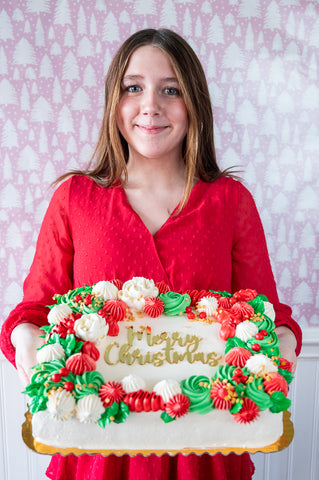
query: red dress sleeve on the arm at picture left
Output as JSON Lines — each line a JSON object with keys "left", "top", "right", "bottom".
{"left": 0, "top": 179, "right": 73, "bottom": 365}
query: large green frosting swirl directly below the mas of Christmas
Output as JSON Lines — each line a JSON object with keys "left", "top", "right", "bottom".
{"left": 180, "top": 375, "right": 214, "bottom": 414}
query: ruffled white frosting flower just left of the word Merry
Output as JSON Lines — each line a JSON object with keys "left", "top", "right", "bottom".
{"left": 74, "top": 313, "right": 109, "bottom": 342}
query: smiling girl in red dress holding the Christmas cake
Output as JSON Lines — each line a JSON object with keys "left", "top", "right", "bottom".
{"left": 1, "top": 29, "right": 301, "bottom": 480}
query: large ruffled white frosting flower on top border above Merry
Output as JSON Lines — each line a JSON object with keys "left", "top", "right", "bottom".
{"left": 118, "top": 277, "right": 158, "bottom": 311}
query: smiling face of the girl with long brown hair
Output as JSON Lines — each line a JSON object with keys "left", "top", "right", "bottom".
{"left": 117, "top": 46, "right": 188, "bottom": 162}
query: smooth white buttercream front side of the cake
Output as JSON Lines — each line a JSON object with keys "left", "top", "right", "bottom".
{"left": 32, "top": 409, "right": 283, "bottom": 452}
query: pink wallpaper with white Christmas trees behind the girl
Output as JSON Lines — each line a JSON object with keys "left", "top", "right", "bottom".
{"left": 0, "top": 0, "right": 319, "bottom": 327}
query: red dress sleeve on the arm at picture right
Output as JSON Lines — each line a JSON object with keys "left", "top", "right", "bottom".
{"left": 232, "top": 182, "right": 302, "bottom": 355}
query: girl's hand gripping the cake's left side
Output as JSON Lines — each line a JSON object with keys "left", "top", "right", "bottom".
{"left": 11, "top": 323, "right": 43, "bottom": 387}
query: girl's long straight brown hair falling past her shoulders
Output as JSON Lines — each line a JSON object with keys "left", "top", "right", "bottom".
{"left": 56, "top": 29, "right": 235, "bottom": 212}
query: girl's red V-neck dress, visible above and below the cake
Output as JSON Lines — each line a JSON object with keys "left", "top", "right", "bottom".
{"left": 1, "top": 176, "right": 301, "bottom": 480}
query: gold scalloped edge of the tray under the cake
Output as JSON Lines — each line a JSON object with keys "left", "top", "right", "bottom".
{"left": 22, "top": 411, "right": 294, "bottom": 457}
